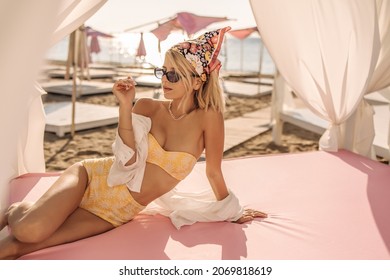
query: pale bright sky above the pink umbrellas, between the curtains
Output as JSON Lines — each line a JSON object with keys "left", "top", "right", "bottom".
{"left": 86, "top": 0, "right": 256, "bottom": 33}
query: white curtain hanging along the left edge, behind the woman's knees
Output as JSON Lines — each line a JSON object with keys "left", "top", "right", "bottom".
{"left": 0, "top": 0, "right": 106, "bottom": 236}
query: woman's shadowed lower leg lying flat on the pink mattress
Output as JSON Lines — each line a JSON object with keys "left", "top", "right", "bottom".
{"left": 0, "top": 208, "right": 114, "bottom": 259}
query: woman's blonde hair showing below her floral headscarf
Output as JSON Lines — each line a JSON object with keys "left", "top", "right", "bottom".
{"left": 165, "top": 49, "right": 225, "bottom": 112}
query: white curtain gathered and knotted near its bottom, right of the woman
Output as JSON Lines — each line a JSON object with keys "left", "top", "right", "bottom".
{"left": 250, "top": 0, "right": 380, "bottom": 151}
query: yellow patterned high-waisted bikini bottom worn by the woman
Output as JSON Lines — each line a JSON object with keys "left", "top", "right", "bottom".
{"left": 80, "top": 157, "right": 145, "bottom": 227}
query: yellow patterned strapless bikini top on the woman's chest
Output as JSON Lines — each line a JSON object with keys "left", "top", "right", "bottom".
{"left": 146, "top": 133, "right": 196, "bottom": 181}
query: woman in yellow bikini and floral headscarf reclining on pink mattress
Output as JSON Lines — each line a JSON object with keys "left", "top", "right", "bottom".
{"left": 0, "top": 28, "right": 267, "bottom": 259}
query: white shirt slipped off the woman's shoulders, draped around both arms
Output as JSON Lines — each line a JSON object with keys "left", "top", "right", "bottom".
{"left": 107, "top": 113, "right": 243, "bottom": 228}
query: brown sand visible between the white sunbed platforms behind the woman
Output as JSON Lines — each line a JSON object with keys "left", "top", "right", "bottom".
{"left": 43, "top": 81, "right": 320, "bottom": 171}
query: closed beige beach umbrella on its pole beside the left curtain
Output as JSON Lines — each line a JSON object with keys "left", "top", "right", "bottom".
{"left": 65, "top": 25, "right": 90, "bottom": 137}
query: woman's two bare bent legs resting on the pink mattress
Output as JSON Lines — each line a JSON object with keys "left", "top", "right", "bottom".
{"left": 0, "top": 163, "right": 113, "bottom": 259}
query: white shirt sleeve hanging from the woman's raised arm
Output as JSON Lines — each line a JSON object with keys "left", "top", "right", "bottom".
{"left": 107, "top": 114, "right": 151, "bottom": 192}
